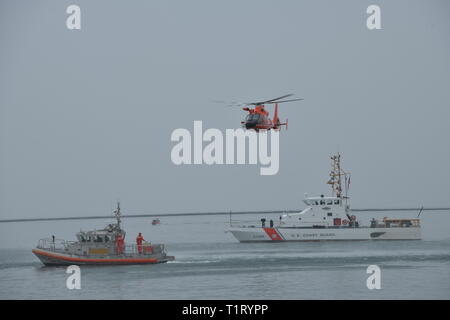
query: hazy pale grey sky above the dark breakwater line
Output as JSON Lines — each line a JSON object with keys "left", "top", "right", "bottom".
{"left": 0, "top": 0, "right": 450, "bottom": 219}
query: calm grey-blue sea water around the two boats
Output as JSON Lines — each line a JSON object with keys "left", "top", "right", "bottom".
{"left": 0, "top": 212, "right": 450, "bottom": 299}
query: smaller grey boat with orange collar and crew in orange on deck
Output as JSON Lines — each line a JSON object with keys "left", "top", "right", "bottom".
{"left": 32, "top": 204, "right": 175, "bottom": 266}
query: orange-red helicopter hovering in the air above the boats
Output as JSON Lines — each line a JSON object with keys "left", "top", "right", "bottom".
{"left": 231, "top": 94, "right": 303, "bottom": 131}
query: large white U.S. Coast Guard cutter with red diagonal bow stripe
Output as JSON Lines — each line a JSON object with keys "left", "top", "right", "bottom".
{"left": 229, "top": 153, "right": 421, "bottom": 242}
